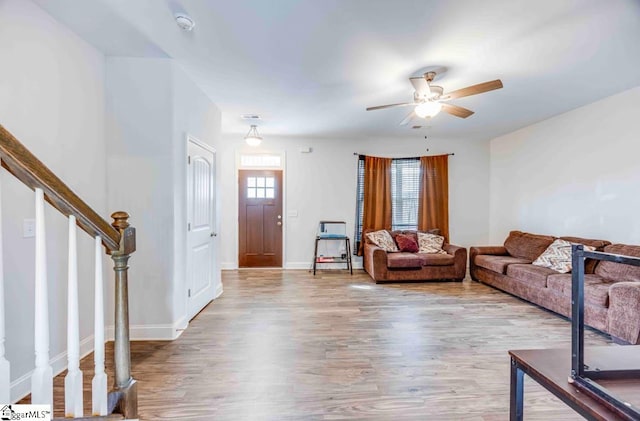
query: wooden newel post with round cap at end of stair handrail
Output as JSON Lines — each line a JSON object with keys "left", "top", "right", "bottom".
{"left": 111, "top": 212, "right": 138, "bottom": 419}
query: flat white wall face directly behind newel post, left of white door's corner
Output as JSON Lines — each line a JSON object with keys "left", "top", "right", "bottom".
{"left": 106, "top": 57, "right": 174, "bottom": 330}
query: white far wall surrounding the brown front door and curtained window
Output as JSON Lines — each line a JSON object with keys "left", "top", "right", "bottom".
{"left": 219, "top": 134, "right": 489, "bottom": 269}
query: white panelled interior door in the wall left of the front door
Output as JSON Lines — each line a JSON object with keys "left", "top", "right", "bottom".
{"left": 187, "top": 138, "right": 217, "bottom": 319}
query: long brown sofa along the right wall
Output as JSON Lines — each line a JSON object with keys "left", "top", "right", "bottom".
{"left": 469, "top": 231, "right": 640, "bottom": 344}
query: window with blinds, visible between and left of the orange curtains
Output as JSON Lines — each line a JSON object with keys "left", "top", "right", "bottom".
{"left": 354, "top": 156, "right": 420, "bottom": 253}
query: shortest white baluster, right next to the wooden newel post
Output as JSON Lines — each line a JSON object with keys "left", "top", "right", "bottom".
{"left": 91, "top": 237, "right": 107, "bottom": 415}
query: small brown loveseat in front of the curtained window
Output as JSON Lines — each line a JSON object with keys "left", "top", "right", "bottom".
{"left": 363, "top": 231, "right": 467, "bottom": 283}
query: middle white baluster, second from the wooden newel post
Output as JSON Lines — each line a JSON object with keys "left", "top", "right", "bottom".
{"left": 64, "top": 215, "right": 84, "bottom": 418}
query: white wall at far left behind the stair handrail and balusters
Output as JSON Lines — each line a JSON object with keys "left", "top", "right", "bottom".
{"left": 0, "top": 0, "right": 110, "bottom": 399}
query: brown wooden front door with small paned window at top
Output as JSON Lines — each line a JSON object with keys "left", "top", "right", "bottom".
{"left": 238, "top": 170, "right": 282, "bottom": 268}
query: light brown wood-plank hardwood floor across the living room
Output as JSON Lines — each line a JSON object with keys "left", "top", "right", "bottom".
{"left": 56, "top": 270, "right": 610, "bottom": 421}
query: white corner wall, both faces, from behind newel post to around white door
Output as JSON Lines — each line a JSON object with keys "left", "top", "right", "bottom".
{"left": 106, "top": 57, "right": 222, "bottom": 339}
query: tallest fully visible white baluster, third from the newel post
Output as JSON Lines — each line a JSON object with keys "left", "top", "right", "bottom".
{"left": 31, "top": 189, "right": 53, "bottom": 407}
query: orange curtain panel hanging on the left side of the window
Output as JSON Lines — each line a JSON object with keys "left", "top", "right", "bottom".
{"left": 358, "top": 156, "right": 391, "bottom": 256}
